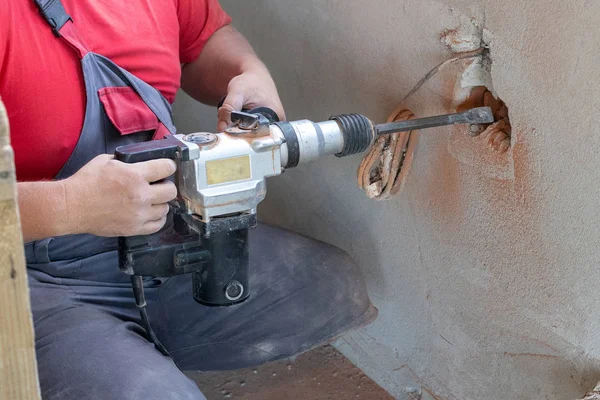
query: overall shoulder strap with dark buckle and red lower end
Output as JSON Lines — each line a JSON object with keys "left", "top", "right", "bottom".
{"left": 33, "top": 0, "right": 89, "bottom": 58}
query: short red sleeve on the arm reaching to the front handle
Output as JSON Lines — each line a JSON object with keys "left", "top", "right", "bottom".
{"left": 177, "top": 0, "right": 231, "bottom": 63}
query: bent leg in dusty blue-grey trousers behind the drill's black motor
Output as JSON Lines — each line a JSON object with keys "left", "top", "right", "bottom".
{"left": 148, "top": 225, "right": 377, "bottom": 370}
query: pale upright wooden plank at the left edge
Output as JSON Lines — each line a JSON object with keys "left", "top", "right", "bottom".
{"left": 0, "top": 100, "right": 41, "bottom": 400}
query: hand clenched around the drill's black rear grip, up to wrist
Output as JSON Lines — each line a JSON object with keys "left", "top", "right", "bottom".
{"left": 64, "top": 154, "right": 177, "bottom": 237}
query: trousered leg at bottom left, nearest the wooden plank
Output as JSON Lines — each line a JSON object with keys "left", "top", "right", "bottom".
{"left": 30, "top": 278, "right": 205, "bottom": 400}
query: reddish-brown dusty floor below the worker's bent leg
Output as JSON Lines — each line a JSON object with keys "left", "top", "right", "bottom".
{"left": 188, "top": 346, "right": 394, "bottom": 400}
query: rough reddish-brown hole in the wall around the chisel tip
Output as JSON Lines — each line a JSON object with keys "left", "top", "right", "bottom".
{"left": 456, "top": 86, "right": 512, "bottom": 153}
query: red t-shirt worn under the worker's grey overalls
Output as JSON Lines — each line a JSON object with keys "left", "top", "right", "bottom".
{"left": 0, "top": 0, "right": 231, "bottom": 181}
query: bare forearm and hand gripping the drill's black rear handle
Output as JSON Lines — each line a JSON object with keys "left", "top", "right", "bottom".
{"left": 17, "top": 154, "right": 177, "bottom": 242}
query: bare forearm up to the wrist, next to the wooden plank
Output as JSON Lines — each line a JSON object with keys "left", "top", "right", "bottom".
{"left": 17, "top": 181, "right": 75, "bottom": 242}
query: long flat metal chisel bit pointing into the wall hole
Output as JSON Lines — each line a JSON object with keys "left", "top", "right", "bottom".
{"left": 375, "top": 107, "right": 494, "bottom": 135}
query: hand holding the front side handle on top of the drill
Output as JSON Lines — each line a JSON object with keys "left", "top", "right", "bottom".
{"left": 217, "top": 67, "right": 285, "bottom": 132}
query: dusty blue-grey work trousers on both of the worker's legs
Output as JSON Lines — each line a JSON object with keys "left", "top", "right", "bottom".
{"left": 27, "top": 225, "right": 377, "bottom": 400}
